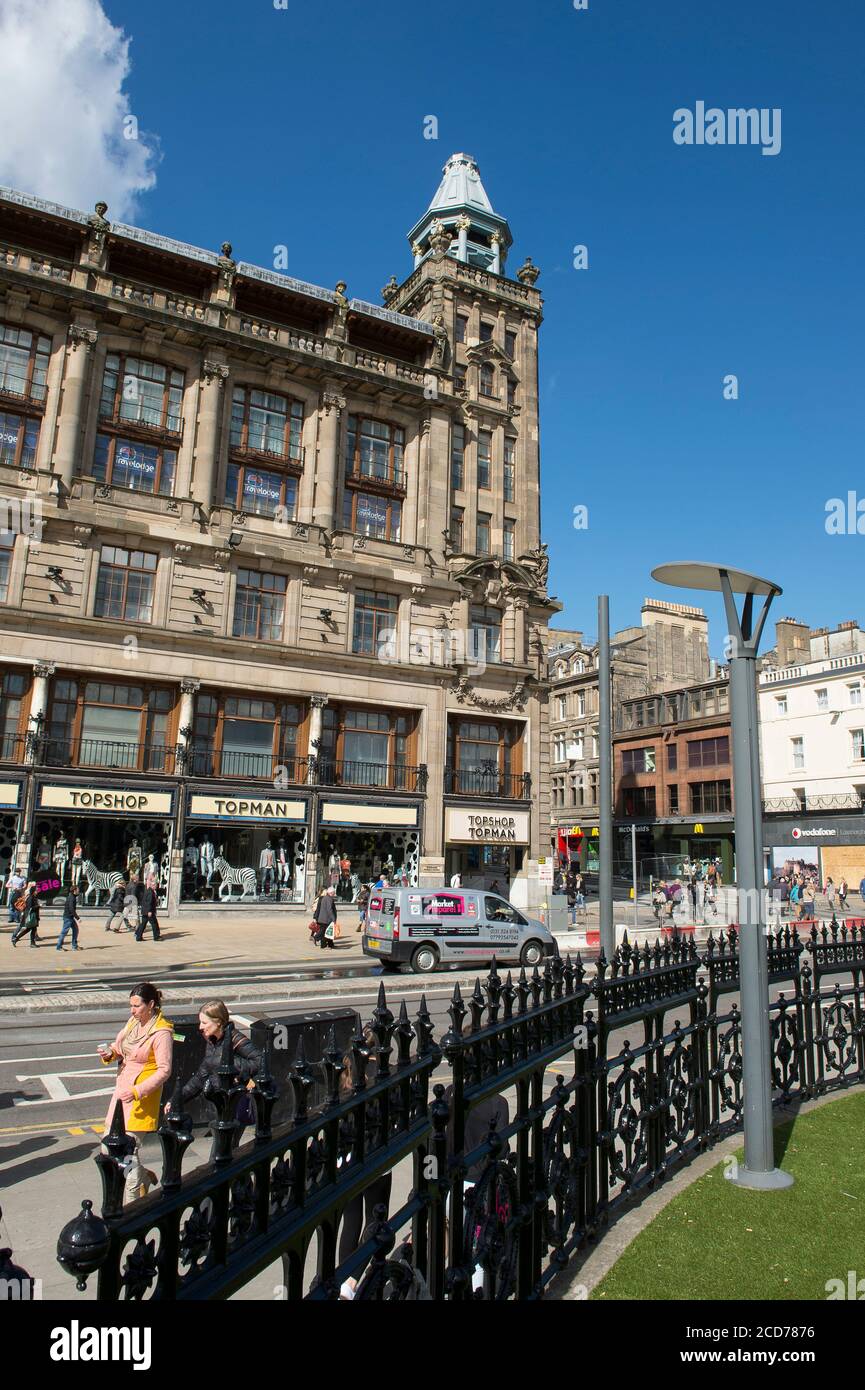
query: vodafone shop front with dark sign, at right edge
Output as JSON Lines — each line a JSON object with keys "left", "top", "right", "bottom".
{"left": 763, "top": 813, "right": 865, "bottom": 892}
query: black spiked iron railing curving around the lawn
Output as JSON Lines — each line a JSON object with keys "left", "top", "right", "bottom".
{"left": 58, "top": 920, "right": 865, "bottom": 1302}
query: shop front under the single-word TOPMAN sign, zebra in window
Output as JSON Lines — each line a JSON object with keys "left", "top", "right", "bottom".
{"left": 179, "top": 787, "right": 309, "bottom": 906}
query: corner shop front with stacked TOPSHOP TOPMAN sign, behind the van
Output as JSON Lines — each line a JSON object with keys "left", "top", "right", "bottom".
{"left": 445, "top": 806, "right": 530, "bottom": 897}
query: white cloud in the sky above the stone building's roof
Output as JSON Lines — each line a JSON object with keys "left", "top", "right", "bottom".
{"left": 0, "top": 0, "right": 159, "bottom": 221}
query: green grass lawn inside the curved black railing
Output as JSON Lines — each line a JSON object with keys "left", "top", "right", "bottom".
{"left": 591, "top": 1093, "right": 865, "bottom": 1300}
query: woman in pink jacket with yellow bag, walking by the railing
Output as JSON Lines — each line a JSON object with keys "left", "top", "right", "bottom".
{"left": 99, "top": 983, "right": 174, "bottom": 1202}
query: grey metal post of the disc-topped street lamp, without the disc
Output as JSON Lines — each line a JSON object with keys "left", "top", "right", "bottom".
{"left": 725, "top": 591, "right": 793, "bottom": 1188}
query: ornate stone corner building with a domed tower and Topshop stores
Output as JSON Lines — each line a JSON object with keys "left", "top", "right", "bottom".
{"left": 0, "top": 156, "right": 559, "bottom": 913}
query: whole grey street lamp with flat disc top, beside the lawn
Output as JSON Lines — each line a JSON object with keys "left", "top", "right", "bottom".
{"left": 652, "top": 562, "right": 793, "bottom": 1190}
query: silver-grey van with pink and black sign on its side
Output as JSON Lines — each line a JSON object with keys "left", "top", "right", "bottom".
{"left": 363, "top": 888, "right": 558, "bottom": 974}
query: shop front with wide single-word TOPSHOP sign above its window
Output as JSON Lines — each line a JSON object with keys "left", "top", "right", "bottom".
{"left": 29, "top": 783, "right": 175, "bottom": 908}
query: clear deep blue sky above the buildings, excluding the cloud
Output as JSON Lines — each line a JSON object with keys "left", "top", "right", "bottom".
{"left": 8, "top": 0, "right": 865, "bottom": 655}
